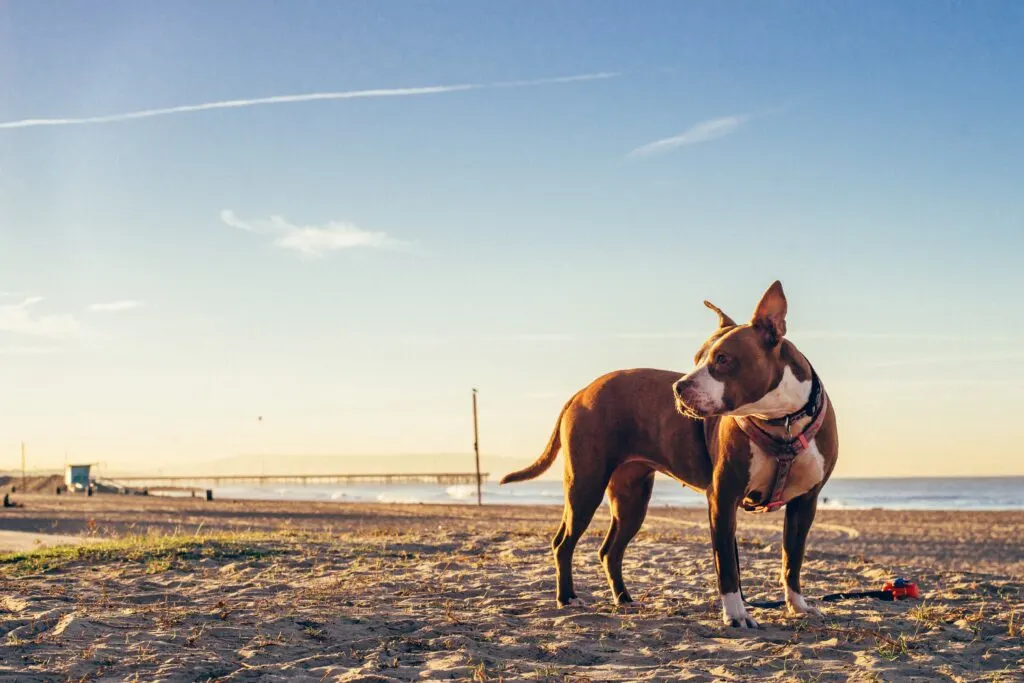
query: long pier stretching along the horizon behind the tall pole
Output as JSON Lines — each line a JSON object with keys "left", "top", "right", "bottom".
{"left": 104, "top": 472, "right": 487, "bottom": 488}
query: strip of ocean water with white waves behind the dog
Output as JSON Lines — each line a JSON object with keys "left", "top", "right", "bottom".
{"left": 214, "top": 476, "right": 1024, "bottom": 510}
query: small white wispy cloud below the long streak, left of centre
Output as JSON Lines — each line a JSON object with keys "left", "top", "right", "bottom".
{"left": 220, "top": 209, "right": 409, "bottom": 258}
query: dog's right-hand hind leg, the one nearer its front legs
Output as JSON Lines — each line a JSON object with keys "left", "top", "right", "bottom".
{"left": 599, "top": 463, "right": 654, "bottom": 605}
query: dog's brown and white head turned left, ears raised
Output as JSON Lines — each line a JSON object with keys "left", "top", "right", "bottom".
{"left": 673, "top": 281, "right": 810, "bottom": 418}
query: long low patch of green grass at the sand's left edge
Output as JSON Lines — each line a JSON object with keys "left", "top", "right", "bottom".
{"left": 0, "top": 533, "right": 281, "bottom": 577}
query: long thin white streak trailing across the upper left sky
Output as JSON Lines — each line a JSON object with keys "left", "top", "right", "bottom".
{"left": 0, "top": 72, "right": 622, "bottom": 130}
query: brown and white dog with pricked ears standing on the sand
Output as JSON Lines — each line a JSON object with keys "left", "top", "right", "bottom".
{"left": 502, "top": 282, "right": 839, "bottom": 628}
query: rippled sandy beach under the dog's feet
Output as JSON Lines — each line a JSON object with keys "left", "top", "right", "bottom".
{"left": 0, "top": 496, "right": 1024, "bottom": 681}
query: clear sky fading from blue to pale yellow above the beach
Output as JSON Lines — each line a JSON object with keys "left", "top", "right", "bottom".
{"left": 0, "top": 0, "right": 1024, "bottom": 475}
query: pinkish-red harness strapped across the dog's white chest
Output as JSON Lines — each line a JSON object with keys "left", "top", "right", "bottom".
{"left": 735, "top": 370, "right": 828, "bottom": 512}
